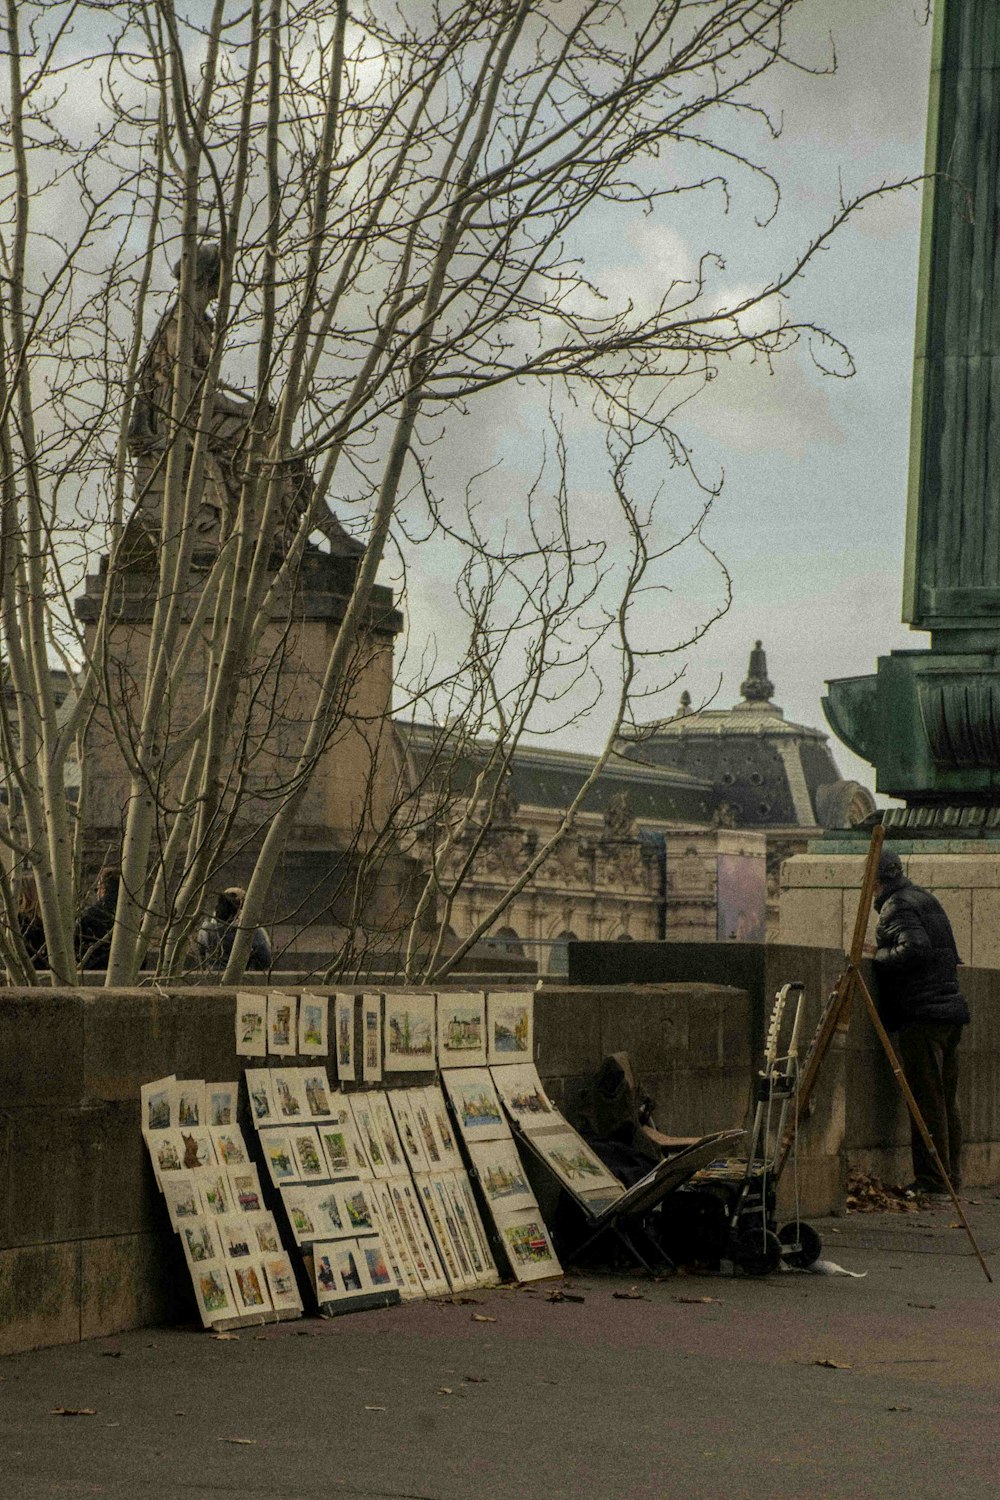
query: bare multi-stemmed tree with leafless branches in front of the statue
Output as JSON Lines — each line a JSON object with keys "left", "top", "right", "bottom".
{"left": 0, "top": 0, "right": 905, "bottom": 984}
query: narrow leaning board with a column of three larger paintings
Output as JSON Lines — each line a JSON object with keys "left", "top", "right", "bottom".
{"left": 444, "top": 1067, "right": 562, "bottom": 1281}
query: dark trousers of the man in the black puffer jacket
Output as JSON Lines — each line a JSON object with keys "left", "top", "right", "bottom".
{"left": 897, "top": 1022, "right": 963, "bottom": 1193}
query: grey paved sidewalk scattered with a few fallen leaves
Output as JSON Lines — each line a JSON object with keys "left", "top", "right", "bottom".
{"left": 0, "top": 1194, "right": 1000, "bottom": 1500}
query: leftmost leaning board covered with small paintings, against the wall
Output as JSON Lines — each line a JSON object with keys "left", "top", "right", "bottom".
{"left": 141, "top": 1076, "right": 301, "bottom": 1329}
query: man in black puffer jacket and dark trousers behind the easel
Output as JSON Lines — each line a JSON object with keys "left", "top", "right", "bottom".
{"left": 874, "top": 851, "right": 969, "bottom": 1194}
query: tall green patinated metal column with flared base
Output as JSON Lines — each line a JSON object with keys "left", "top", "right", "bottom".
{"left": 823, "top": 0, "right": 1000, "bottom": 837}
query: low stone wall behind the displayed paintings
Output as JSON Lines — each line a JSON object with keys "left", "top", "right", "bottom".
{"left": 0, "top": 981, "right": 750, "bottom": 1353}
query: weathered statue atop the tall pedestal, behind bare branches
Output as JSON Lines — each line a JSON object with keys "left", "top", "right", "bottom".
{"left": 127, "top": 243, "right": 363, "bottom": 557}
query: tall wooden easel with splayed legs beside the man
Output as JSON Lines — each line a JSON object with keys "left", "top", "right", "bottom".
{"left": 777, "top": 827, "right": 993, "bottom": 1281}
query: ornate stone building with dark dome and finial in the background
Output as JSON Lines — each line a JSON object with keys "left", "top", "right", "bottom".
{"left": 396, "top": 642, "right": 874, "bottom": 974}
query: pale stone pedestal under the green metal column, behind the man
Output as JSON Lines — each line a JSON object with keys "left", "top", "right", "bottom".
{"left": 780, "top": 839, "right": 1000, "bottom": 969}
